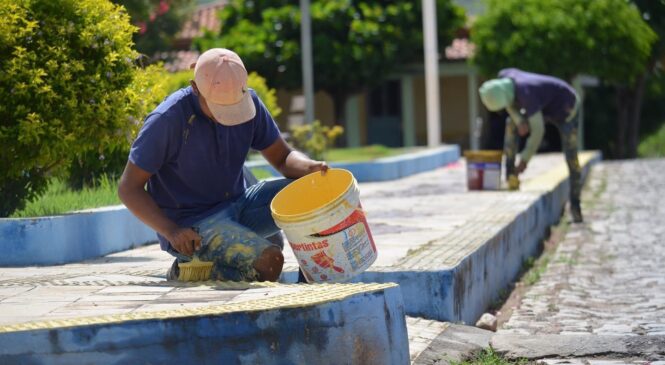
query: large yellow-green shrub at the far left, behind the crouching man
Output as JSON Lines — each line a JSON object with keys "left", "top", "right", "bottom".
{"left": 0, "top": 0, "right": 137, "bottom": 216}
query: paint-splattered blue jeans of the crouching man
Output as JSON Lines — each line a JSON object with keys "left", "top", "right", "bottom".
{"left": 167, "top": 179, "right": 291, "bottom": 281}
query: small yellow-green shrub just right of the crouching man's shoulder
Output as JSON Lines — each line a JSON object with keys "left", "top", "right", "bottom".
{"left": 291, "top": 120, "right": 344, "bottom": 160}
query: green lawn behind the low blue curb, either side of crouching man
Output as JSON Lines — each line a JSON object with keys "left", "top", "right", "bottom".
{"left": 11, "top": 145, "right": 418, "bottom": 218}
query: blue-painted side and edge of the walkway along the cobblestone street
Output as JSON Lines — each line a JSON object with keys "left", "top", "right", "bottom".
{"left": 352, "top": 153, "right": 601, "bottom": 324}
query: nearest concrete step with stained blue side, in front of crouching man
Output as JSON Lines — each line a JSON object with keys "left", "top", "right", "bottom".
{"left": 0, "top": 273, "right": 409, "bottom": 364}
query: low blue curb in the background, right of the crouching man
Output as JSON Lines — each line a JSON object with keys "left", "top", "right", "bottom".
{"left": 245, "top": 145, "right": 460, "bottom": 182}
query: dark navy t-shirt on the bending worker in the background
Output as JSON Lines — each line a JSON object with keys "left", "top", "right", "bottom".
{"left": 499, "top": 68, "right": 577, "bottom": 122}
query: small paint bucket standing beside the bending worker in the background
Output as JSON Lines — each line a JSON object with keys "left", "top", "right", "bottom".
{"left": 464, "top": 150, "right": 503, "bottom": 190}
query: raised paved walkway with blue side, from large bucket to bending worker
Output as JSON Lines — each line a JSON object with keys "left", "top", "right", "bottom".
{"left": 283, "top": 152, "right": 600, "bottom": 324}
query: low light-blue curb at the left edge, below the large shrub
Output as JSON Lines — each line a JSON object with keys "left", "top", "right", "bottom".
{"left": 0, "top": 205, "right": 157, "bottom": 266}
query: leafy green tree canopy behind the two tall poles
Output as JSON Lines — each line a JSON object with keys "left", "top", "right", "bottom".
{"left": 196, "top": 0, "right": 464, "bottom": 116}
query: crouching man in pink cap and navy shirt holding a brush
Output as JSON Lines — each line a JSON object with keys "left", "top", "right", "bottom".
{"left": 118, "top": 48, "right": 328, "bottom": 281}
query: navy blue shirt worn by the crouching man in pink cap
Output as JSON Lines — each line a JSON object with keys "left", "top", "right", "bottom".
{"left": 129, "top": 87, "right": 279, "bottom": 230}
